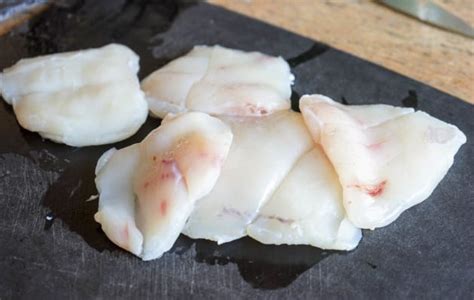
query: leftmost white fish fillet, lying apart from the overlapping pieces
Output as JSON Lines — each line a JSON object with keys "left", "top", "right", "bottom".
{"left": 0, "top": 44, "right": 148, "bottom": 146}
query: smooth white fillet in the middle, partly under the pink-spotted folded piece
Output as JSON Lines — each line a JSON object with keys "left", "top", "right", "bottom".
{"left": 183, "top": 111, "right": 313, "bottom": 243}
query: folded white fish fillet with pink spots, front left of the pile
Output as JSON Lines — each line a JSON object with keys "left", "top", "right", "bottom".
{"left": 96, "top": 112, "right": 232, "bottom": 260}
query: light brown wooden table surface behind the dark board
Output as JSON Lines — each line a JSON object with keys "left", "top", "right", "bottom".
{"left": 0, "top": 0, "right": 474, "bottom": 103}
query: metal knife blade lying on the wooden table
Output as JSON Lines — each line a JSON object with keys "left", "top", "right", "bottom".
{"left": 379, "top": 0, "right": 474, "bottom": 38}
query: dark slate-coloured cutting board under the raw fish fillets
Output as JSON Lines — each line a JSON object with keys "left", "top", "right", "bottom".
{"left": 0, "top": 0, "right": 474, "bottom": 299}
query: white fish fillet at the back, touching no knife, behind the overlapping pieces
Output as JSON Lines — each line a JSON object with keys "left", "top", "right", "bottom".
{"left": 142, "top": 46, "right": 294, "bottom": 118}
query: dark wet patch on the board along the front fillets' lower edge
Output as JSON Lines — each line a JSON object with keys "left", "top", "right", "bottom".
{"left": 171, "top": 235, "right": 340, "bottom": 289}
